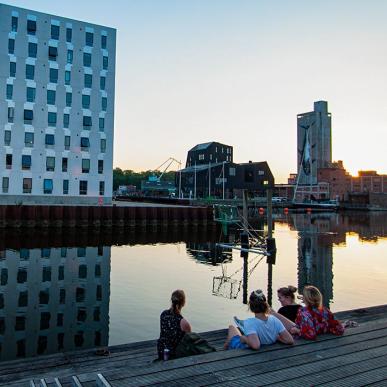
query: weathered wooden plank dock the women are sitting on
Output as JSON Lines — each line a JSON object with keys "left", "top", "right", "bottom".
{"left": 0, "top": 305, "right": 387, "bottom": 387}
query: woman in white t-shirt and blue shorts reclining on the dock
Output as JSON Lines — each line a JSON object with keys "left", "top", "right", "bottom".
{"left": 224, "top": 290, "right": 294, "bottom": 350}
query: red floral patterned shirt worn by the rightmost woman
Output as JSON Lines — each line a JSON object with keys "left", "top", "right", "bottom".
{"left": 296, "top": 306, "right": 344, "bottom": 340}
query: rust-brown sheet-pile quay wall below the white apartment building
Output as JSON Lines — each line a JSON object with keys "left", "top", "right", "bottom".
{"left": 0, "top": 205, "right": 214, "bottom": 228}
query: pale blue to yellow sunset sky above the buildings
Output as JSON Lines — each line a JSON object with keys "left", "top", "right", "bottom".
{"left": 6, "top": 0, "right": 387, "bottom": 182}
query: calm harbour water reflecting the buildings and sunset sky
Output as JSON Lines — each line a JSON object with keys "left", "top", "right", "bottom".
{"left": 0, "top": 213, "right": 387, "bottom": 360}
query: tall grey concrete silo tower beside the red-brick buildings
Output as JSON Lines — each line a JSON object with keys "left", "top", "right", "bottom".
{"left": 297, "top": 101, "right": 332, "bottom": 185}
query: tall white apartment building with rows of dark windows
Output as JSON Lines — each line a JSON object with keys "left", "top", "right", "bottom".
{"left": 0, "top": 4, "right": 116, "bottom": 204}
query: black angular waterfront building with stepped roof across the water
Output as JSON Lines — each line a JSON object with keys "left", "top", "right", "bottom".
{"left": 180, "top": 142, "right": 274, "bottom": 199}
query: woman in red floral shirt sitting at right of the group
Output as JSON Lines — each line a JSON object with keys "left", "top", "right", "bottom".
{"left": 295, "top": 285, "right": 344, "bottom": 340}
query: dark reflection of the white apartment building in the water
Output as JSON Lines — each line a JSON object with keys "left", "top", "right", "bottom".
{"left": 0, "top": 246, "right": 111, "bottom": 360}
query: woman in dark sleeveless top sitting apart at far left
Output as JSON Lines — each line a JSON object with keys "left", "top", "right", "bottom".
{"left": 157, "top": 290, "right": 191, "bottom": 360}
